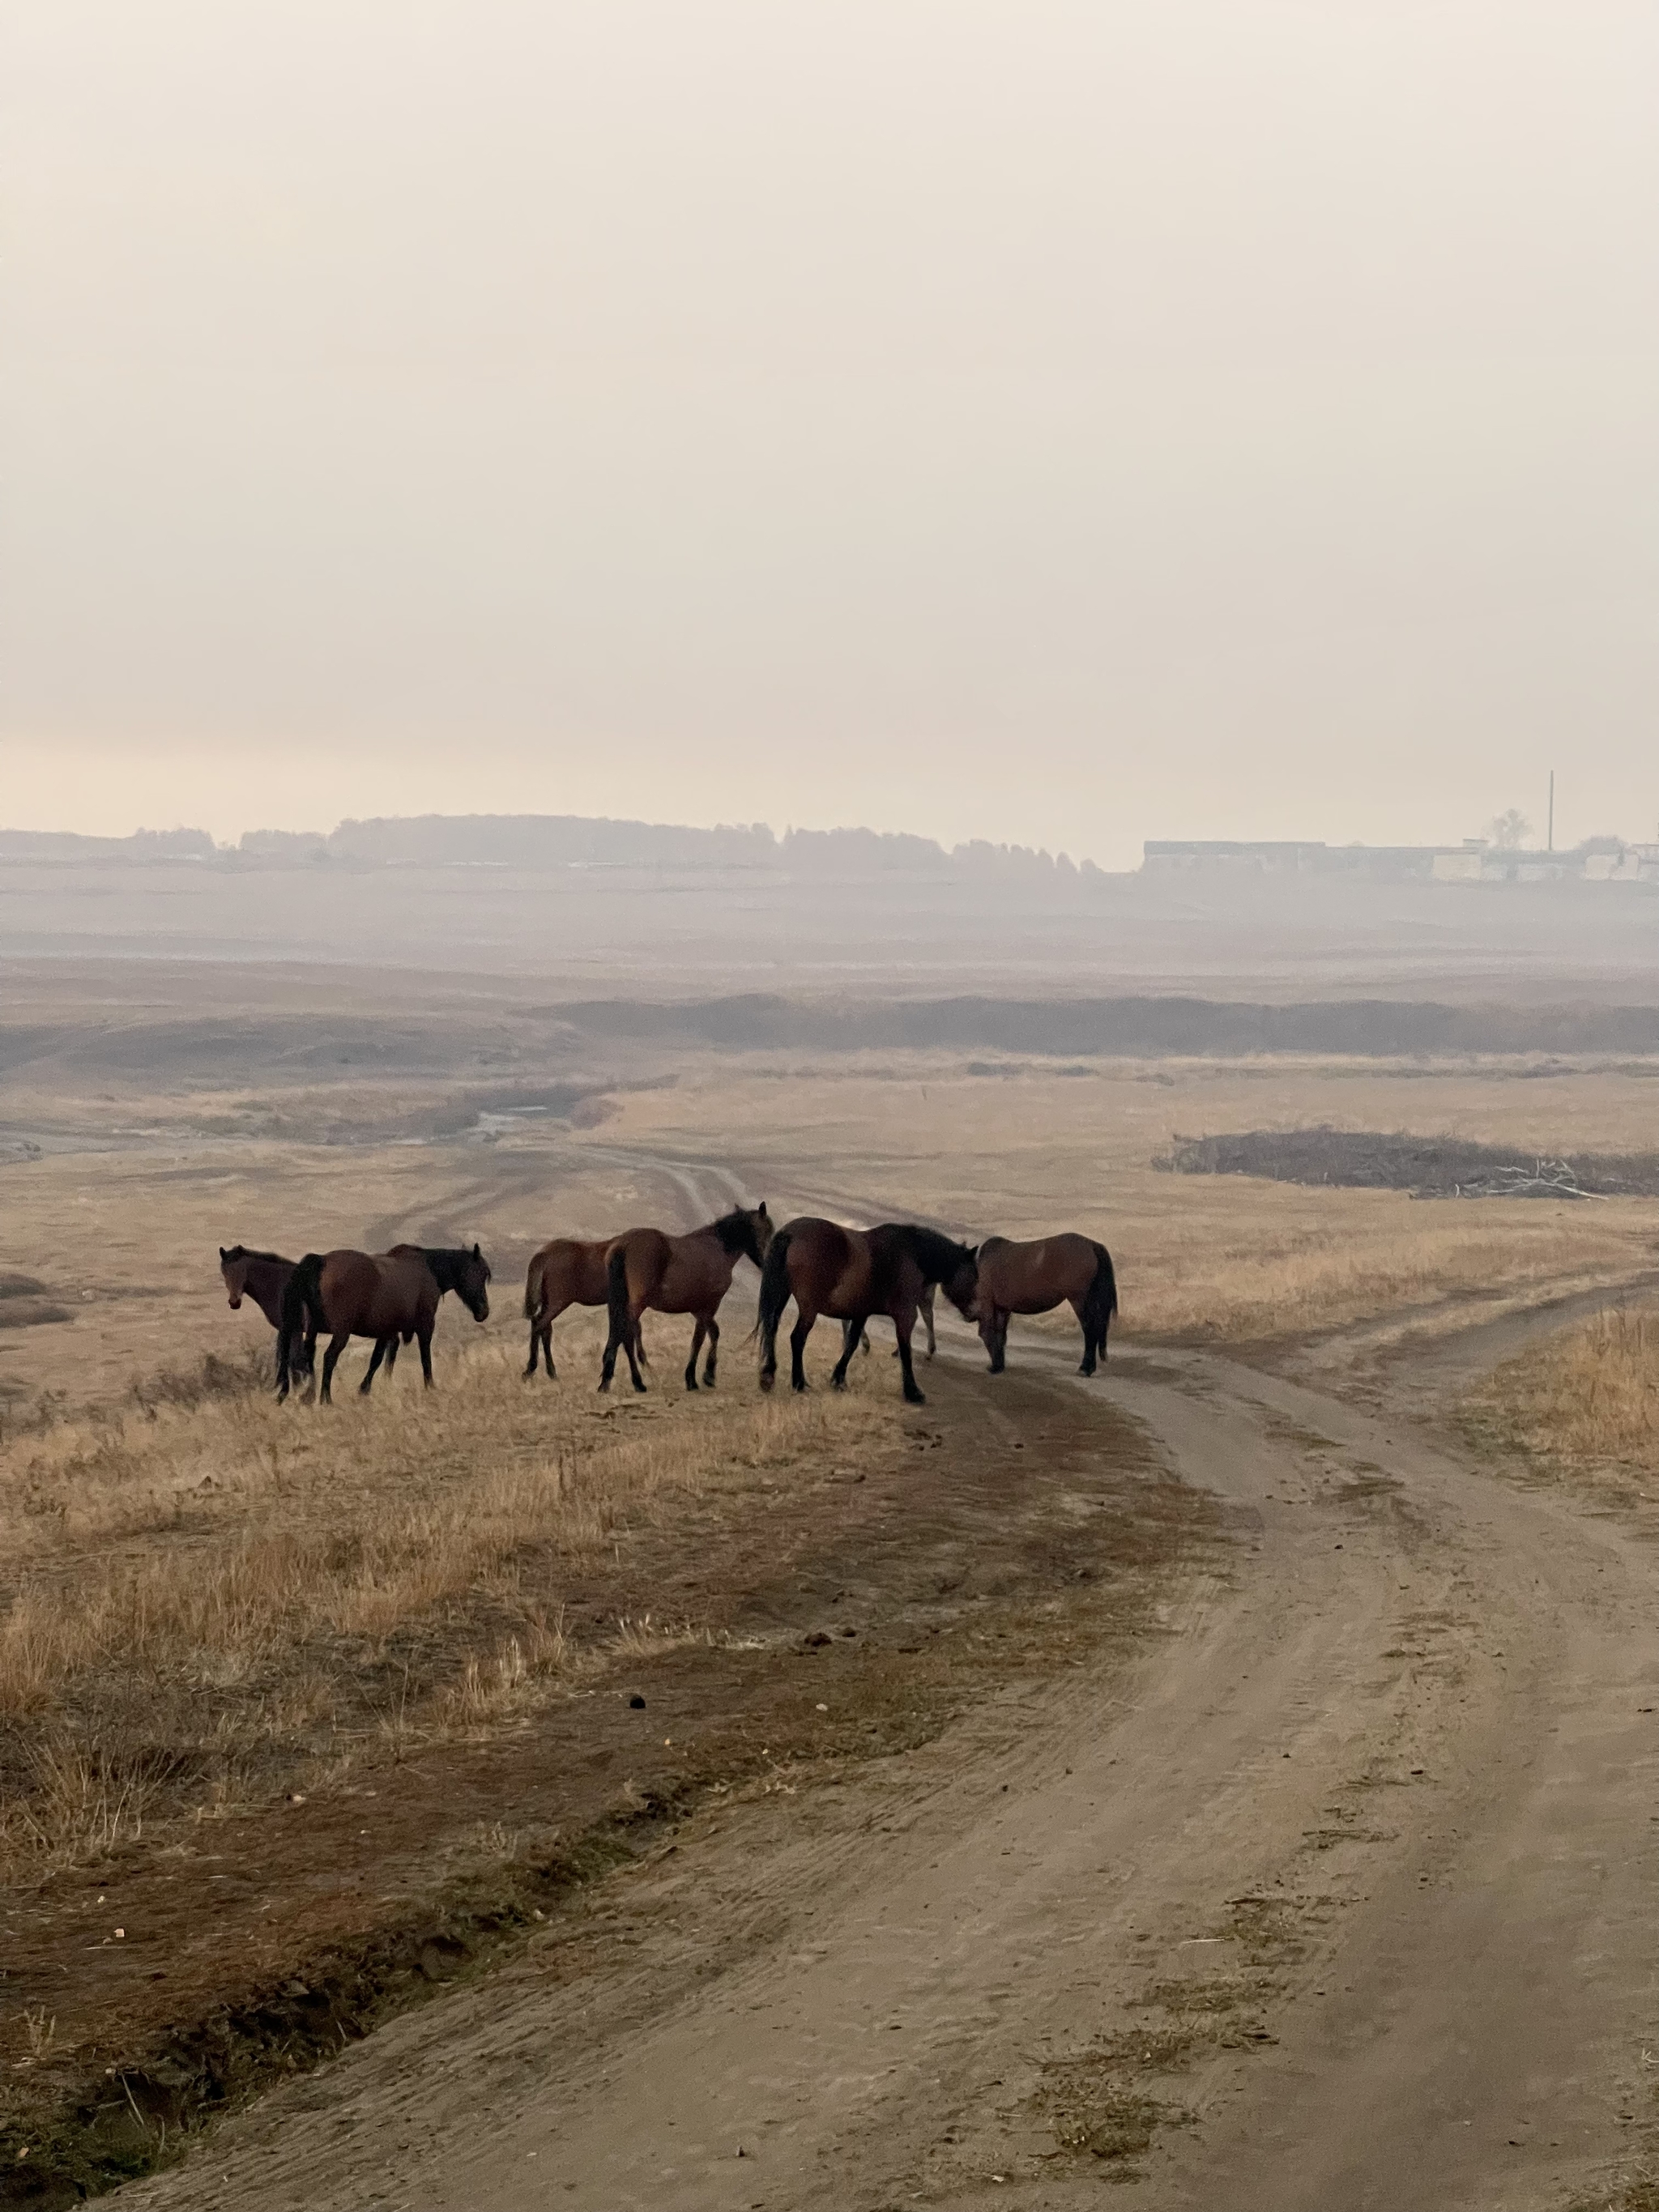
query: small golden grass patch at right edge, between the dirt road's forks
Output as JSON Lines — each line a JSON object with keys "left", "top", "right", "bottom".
{"left": 1465, "top": 1305, "right": 1659, "bottom": 1482}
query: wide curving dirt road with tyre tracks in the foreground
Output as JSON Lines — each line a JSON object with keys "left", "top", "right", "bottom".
{"left": 128, "top": 1323, "right": 1659, "bottom": 2212}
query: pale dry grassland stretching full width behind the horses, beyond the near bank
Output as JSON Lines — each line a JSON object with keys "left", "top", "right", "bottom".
{"left": 0, "top": 1055, "right": 1659, "bottom": 1418}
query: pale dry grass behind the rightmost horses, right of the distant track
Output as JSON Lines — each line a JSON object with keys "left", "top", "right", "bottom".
{"left": 608, "top": 1055, "right": 1659, "bottom": 1340}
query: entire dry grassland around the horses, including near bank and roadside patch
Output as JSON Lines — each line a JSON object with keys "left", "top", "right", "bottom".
{"left": 0, "top": 1030, "right": 1659, "bottom": 2172}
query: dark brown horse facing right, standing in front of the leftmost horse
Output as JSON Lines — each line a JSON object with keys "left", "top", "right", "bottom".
{"left": 276, "top": 1246, "right": 488, "bottom": 1404}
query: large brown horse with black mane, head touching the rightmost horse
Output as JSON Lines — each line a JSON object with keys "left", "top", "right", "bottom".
{"left": 757, "top": 1214, "right": 978, "bottom": 1404}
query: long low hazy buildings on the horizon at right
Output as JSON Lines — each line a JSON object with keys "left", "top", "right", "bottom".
{"left": 1141, "top": 838, "right": 1659, "bottom": 883}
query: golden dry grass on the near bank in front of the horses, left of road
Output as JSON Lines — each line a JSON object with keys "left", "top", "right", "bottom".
{"left": 0, "top": 1325, "right": 893, "bottom": 1871}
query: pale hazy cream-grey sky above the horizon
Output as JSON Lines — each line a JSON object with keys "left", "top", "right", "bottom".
{"left": 0, "top": 0, "right": 1659, "bottom": 865}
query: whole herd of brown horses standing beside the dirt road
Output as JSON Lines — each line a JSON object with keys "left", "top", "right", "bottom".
{"left": 219, "top": 1201, "right": 1117, "bottom": 1404}
